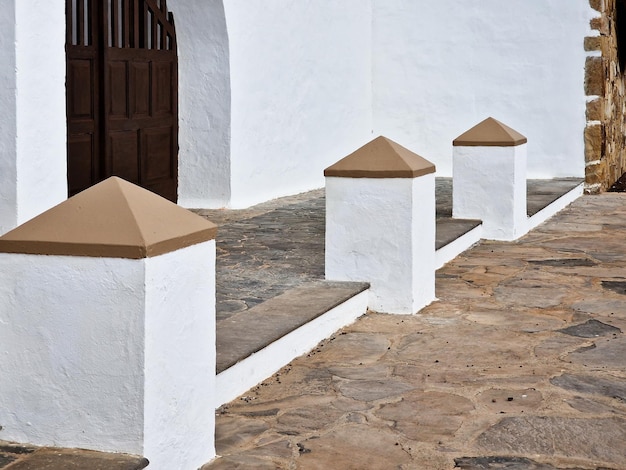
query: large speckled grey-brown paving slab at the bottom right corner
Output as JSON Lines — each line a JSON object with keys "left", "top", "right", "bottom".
{"left": 476, "top": 416, "right": 626, "bottom": 465}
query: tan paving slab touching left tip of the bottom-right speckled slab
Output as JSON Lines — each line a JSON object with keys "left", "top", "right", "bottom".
{"left": 375, "top": 392, "right": 474, "bottom": 442}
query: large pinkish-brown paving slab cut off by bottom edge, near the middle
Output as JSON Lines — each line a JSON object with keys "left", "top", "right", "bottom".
{"left": 298, "top": 424, "right": 411, "bottom": 470}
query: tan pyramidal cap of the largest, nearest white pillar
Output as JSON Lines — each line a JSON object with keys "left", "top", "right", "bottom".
{"left": 0, "top": 177, "right": 217, "bottom": 259}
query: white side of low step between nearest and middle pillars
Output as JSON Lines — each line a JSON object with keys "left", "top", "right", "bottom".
{"left": 215, "top": 290, "right": 368, "bottom": 407}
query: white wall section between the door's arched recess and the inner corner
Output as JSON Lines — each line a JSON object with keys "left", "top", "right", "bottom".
{"left": 225, "top": 0, "right": 372, "bottom": 207}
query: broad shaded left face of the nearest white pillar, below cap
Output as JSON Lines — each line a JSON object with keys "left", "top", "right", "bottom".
{"left": 0, "top": 253, "right": 145, "bottom": 455}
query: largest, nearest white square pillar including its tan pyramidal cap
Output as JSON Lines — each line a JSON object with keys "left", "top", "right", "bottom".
{"left": 0, "top": 177, "right": 217, "bottom": 469}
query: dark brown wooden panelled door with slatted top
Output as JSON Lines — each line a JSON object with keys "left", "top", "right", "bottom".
{"left": 66, "top": 0, "right": 178, "bottom": 201}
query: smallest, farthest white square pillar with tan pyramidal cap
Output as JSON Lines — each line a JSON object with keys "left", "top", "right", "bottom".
{"left": 452, "top": 117, "right": 528, "bottom": 240}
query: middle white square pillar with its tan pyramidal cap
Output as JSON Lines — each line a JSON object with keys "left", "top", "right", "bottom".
{"left": 324, "top": 137, "right": 435, "bottom": 314}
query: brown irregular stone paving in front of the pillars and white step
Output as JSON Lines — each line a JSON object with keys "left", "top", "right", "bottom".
{"left": 204, "top": 193, "right": 626, "bottom": 470}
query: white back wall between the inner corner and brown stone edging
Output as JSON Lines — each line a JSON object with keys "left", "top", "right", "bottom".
{"left": 373, "top": 0, "right": 592, "bottom": 177}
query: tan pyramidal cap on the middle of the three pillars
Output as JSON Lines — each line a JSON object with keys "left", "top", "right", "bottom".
{"left": 324, "top": 136, "right": 435, "bottom": 178}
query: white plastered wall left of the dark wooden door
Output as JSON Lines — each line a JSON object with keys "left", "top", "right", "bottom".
{"left": 0, "top": 0, "right": 67, "bottom": 233}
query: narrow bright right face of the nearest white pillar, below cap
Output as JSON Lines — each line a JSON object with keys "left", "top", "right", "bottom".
{"left": 142, "top": 240, "right": 216, "bottom": 470}
